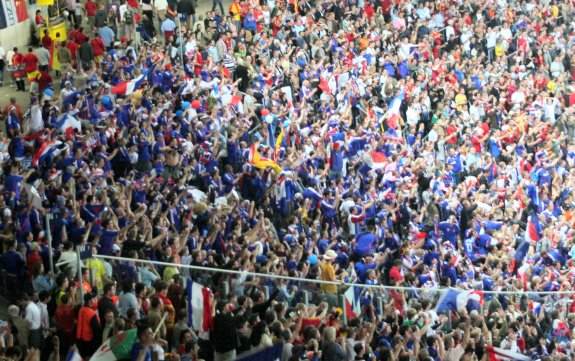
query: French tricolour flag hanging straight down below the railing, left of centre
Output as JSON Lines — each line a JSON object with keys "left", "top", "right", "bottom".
{"left": 187, "top": 278, "right": 213, "bottom": 332}
